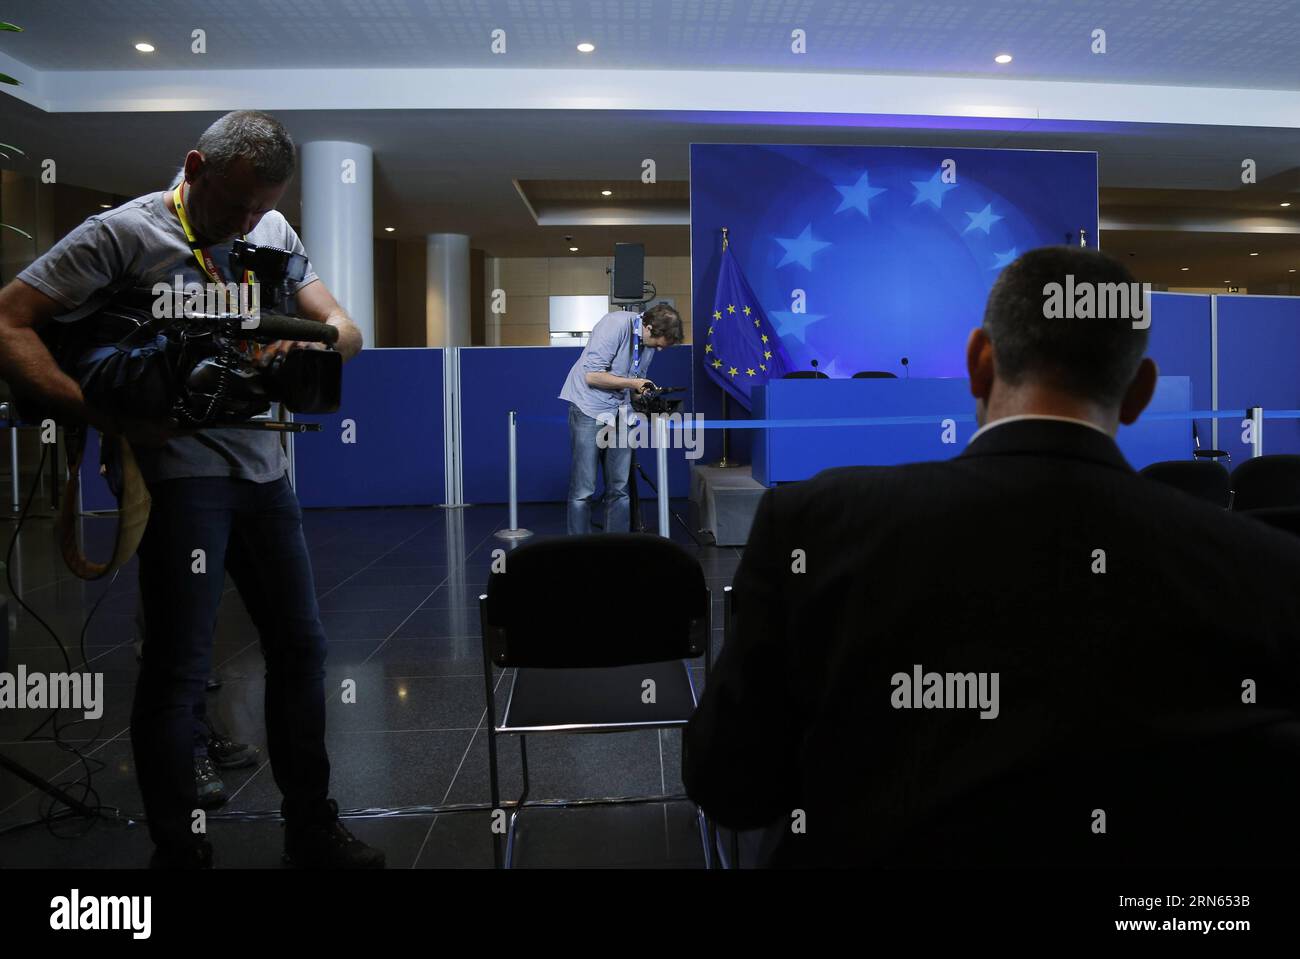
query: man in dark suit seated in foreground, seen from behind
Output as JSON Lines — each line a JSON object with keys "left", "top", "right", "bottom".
{"left": 683, "top": 247, "right": 1300, "bottom": 865}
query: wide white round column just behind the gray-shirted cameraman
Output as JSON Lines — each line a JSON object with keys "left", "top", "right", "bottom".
{"left": 302, "top": 140, "right": 374, "bottom": 347}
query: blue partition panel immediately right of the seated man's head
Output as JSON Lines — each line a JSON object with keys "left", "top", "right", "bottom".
{"left": 1147, "top": 292, "right": 1223, "bottom": 459}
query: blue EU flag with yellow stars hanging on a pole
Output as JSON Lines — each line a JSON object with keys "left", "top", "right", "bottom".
{"left": 703, "top": 246, "right": 794, "bottom": 409}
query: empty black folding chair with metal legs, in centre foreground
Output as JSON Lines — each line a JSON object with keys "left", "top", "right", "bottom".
{"left": 478, "top": 533, "right": 714, "bottom": 868}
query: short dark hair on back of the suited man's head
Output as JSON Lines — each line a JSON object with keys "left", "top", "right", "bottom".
{"left": 984, "top": 247, "right": 1148, "bottom": 407}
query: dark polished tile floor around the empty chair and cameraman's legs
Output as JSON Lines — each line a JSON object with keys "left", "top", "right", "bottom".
{"left": 0, "top": 493, "right": 740, "bottom": 868}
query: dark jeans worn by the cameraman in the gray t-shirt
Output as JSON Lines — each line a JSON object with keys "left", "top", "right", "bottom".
{"left": 131, "top": 477, "right": 329, "bottom": 846}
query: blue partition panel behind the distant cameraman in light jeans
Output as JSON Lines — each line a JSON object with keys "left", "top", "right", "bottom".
{"left": 460, "top": 346, "right": 690, "bottom": 503}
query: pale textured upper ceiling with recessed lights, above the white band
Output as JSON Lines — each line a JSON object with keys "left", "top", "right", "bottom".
{"left": 0, "top": 0, "right": 1300, "bottom": 90}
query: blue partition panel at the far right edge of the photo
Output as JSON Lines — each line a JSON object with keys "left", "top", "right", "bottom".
{"left": 1218, "top": 296, "right": 1300, "bottom": 465}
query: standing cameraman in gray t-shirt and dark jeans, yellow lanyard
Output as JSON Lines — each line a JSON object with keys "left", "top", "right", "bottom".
{"left": 0, "top": 110, "right": 384, "bottom": 868}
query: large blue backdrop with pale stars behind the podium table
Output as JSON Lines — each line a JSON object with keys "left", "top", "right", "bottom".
{"left": 690, "top": 144, "right": 1097, "bottom": 392}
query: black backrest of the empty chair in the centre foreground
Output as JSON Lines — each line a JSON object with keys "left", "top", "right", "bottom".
{"left": 481, "top": 533, "right": 710, "bottom": 669}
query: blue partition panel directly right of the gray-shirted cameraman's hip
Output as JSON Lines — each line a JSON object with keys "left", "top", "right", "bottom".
{"left": 294, "top": 348, "right": 446, "bottom": 507}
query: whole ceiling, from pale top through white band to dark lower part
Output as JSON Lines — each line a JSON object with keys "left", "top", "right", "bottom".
{"left": 0, "top": 0, "right": 1300, "bottom": 282}
